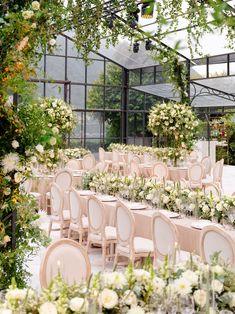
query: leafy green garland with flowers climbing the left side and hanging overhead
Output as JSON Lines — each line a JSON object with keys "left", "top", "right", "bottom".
{"left": 0, "top": 0, "right": 235, "bottom": 285}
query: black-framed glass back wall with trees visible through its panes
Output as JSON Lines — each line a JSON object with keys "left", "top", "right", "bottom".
{"left": 35, "top": 36, "right": 168, "bottom": 151}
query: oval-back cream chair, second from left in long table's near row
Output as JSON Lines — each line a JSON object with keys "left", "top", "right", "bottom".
{"left": 68, "top": 188, "right": 88, "bottom": 244}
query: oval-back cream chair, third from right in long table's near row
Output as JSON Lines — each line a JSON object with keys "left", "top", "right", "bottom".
{"left": 114, "top": 201, "right": 153, "bottom": 266}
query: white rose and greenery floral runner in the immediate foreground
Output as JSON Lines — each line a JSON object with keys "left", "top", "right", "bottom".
{"left": 0, "top": 257, "right": 235, "bottom": 314}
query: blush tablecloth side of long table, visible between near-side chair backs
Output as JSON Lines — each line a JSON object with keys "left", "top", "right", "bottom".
{"left": 77, "top": 196, "right": 235, "bottom": 254}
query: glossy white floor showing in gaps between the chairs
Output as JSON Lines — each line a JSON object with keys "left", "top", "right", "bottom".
{"left": 28, "top": 166, "right": 235, "bottom": 289}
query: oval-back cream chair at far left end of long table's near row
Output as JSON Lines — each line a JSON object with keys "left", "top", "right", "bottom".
{"left": 48, "top": 183, "right": 70, "bottom": 238}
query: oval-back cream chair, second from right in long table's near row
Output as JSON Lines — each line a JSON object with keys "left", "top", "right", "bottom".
{"left": 152, "top": 212, "right": 190, "bottom": 264}
